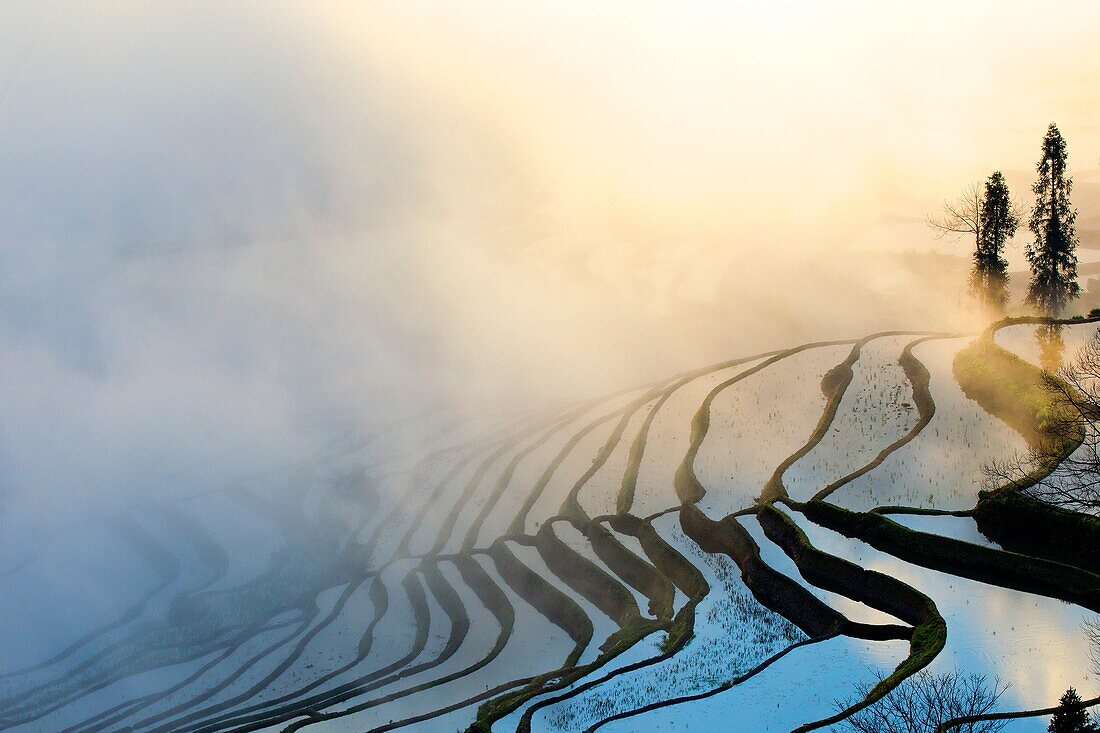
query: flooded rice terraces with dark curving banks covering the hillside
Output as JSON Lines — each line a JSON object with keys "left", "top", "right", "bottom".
{"left": 0, "top": 316, "right": 1100, "bottom": 733}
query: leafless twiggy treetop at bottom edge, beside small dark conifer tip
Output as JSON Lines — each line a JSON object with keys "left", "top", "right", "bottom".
{"left": 837, "top": 670, "right": 1008, "bottom": 733}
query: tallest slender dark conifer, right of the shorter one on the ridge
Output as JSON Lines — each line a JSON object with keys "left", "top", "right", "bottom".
{"left": 1026, "top": 122, "right": 1081, "bottom": 316}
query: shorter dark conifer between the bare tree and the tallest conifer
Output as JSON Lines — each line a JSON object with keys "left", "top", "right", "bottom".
{"left": 970, "top": 171, "right": 1020, "bottom": 310}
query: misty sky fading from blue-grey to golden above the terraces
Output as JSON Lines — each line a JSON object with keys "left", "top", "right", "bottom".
{"left": 0, "top": 0, "right": 1100, "bottom": 511}
